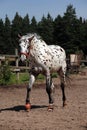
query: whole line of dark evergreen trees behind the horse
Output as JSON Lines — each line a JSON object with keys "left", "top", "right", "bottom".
{"left": 0, "top": 5, "right": 87, "bottom": 55}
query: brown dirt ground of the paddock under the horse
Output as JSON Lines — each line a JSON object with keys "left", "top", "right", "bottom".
{"left": 0, "top": 73, "right": 87, "bottom": 130}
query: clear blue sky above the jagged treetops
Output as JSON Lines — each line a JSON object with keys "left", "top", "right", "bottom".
{"left": 0, "top": 0, "right": 87, "bottom": 21}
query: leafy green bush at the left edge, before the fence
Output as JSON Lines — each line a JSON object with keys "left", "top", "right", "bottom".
{"left": 0, "top": 61, "right": 11, "bottom": 85}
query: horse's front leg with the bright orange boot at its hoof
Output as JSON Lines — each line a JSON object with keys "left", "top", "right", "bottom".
{"left": 25, "top": 74, "right": 35, "bottom": 110}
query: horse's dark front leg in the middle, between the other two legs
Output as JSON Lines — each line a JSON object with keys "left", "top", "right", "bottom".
{"left": 46, "top": 76, "right": 54, "bottom": 111}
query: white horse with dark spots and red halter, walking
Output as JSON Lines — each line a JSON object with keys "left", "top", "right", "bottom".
{"left": 19, "top": 34, "right": 67, "bottom": 111}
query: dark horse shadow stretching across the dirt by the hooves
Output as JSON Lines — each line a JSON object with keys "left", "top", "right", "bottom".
{"left": 0, "top": 105, "right": 48, "bottom": 112}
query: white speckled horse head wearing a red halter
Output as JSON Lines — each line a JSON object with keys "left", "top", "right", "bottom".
{"left": 18, "top": 35, "right": 34, "bottom": 61}
